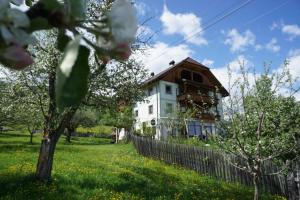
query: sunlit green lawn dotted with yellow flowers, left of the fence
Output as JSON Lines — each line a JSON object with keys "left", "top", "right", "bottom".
{"left": 0, "top": 133, "right": 281, "bottom": 200}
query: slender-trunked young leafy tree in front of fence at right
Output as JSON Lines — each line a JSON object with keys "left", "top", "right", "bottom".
{"left": 219, "top": 65, "right": 300, "bottom": 199}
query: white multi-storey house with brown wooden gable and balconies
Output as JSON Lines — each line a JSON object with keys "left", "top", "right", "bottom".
{"left": 133, "top": 58, "right": 229, "bottom": 139}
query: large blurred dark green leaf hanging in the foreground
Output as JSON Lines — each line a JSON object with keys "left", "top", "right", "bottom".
{"left": 56, "top": 36, "right": 89, "bottom": 110}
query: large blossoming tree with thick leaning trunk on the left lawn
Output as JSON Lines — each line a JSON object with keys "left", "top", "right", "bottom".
{"left": 6, "top": 32, "right": 146, "bottom": 180}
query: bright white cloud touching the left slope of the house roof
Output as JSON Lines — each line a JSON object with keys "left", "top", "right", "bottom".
{"left": 133, "top": 42, "right": 194, "bottom": 74}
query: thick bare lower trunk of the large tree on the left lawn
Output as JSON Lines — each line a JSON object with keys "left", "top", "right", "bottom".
{"left": 35, "top": 134, "right": 58, "bottom": 182}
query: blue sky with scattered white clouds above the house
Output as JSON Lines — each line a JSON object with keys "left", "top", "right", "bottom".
{"left": 135, "top": 0, "right": 300, "bottom": 98}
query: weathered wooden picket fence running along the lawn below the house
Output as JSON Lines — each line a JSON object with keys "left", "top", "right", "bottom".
{"left": 129, "top": 135, "right": 289, "bottom": 196}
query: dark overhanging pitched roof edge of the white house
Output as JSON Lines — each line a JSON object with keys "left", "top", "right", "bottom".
{"left": 142, "top": 57, "right": 229, "bottom": 96}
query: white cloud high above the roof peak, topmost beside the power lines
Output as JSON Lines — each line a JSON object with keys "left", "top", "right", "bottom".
{"left": 160, "top": 5, "right": 207, "bottom": 46}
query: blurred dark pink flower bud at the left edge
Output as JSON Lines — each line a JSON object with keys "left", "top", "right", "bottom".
{"left": 2, "top": 45, "right": 33, "bottom": 70}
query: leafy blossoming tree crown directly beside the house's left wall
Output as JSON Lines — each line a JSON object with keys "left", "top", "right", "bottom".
{"left": 97, "top": 59, "right": 149, "bottom": 140}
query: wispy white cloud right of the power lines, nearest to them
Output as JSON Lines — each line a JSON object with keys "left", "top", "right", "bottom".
{"left": 224, "top": 29, "right": 258, "bottom": 52}
